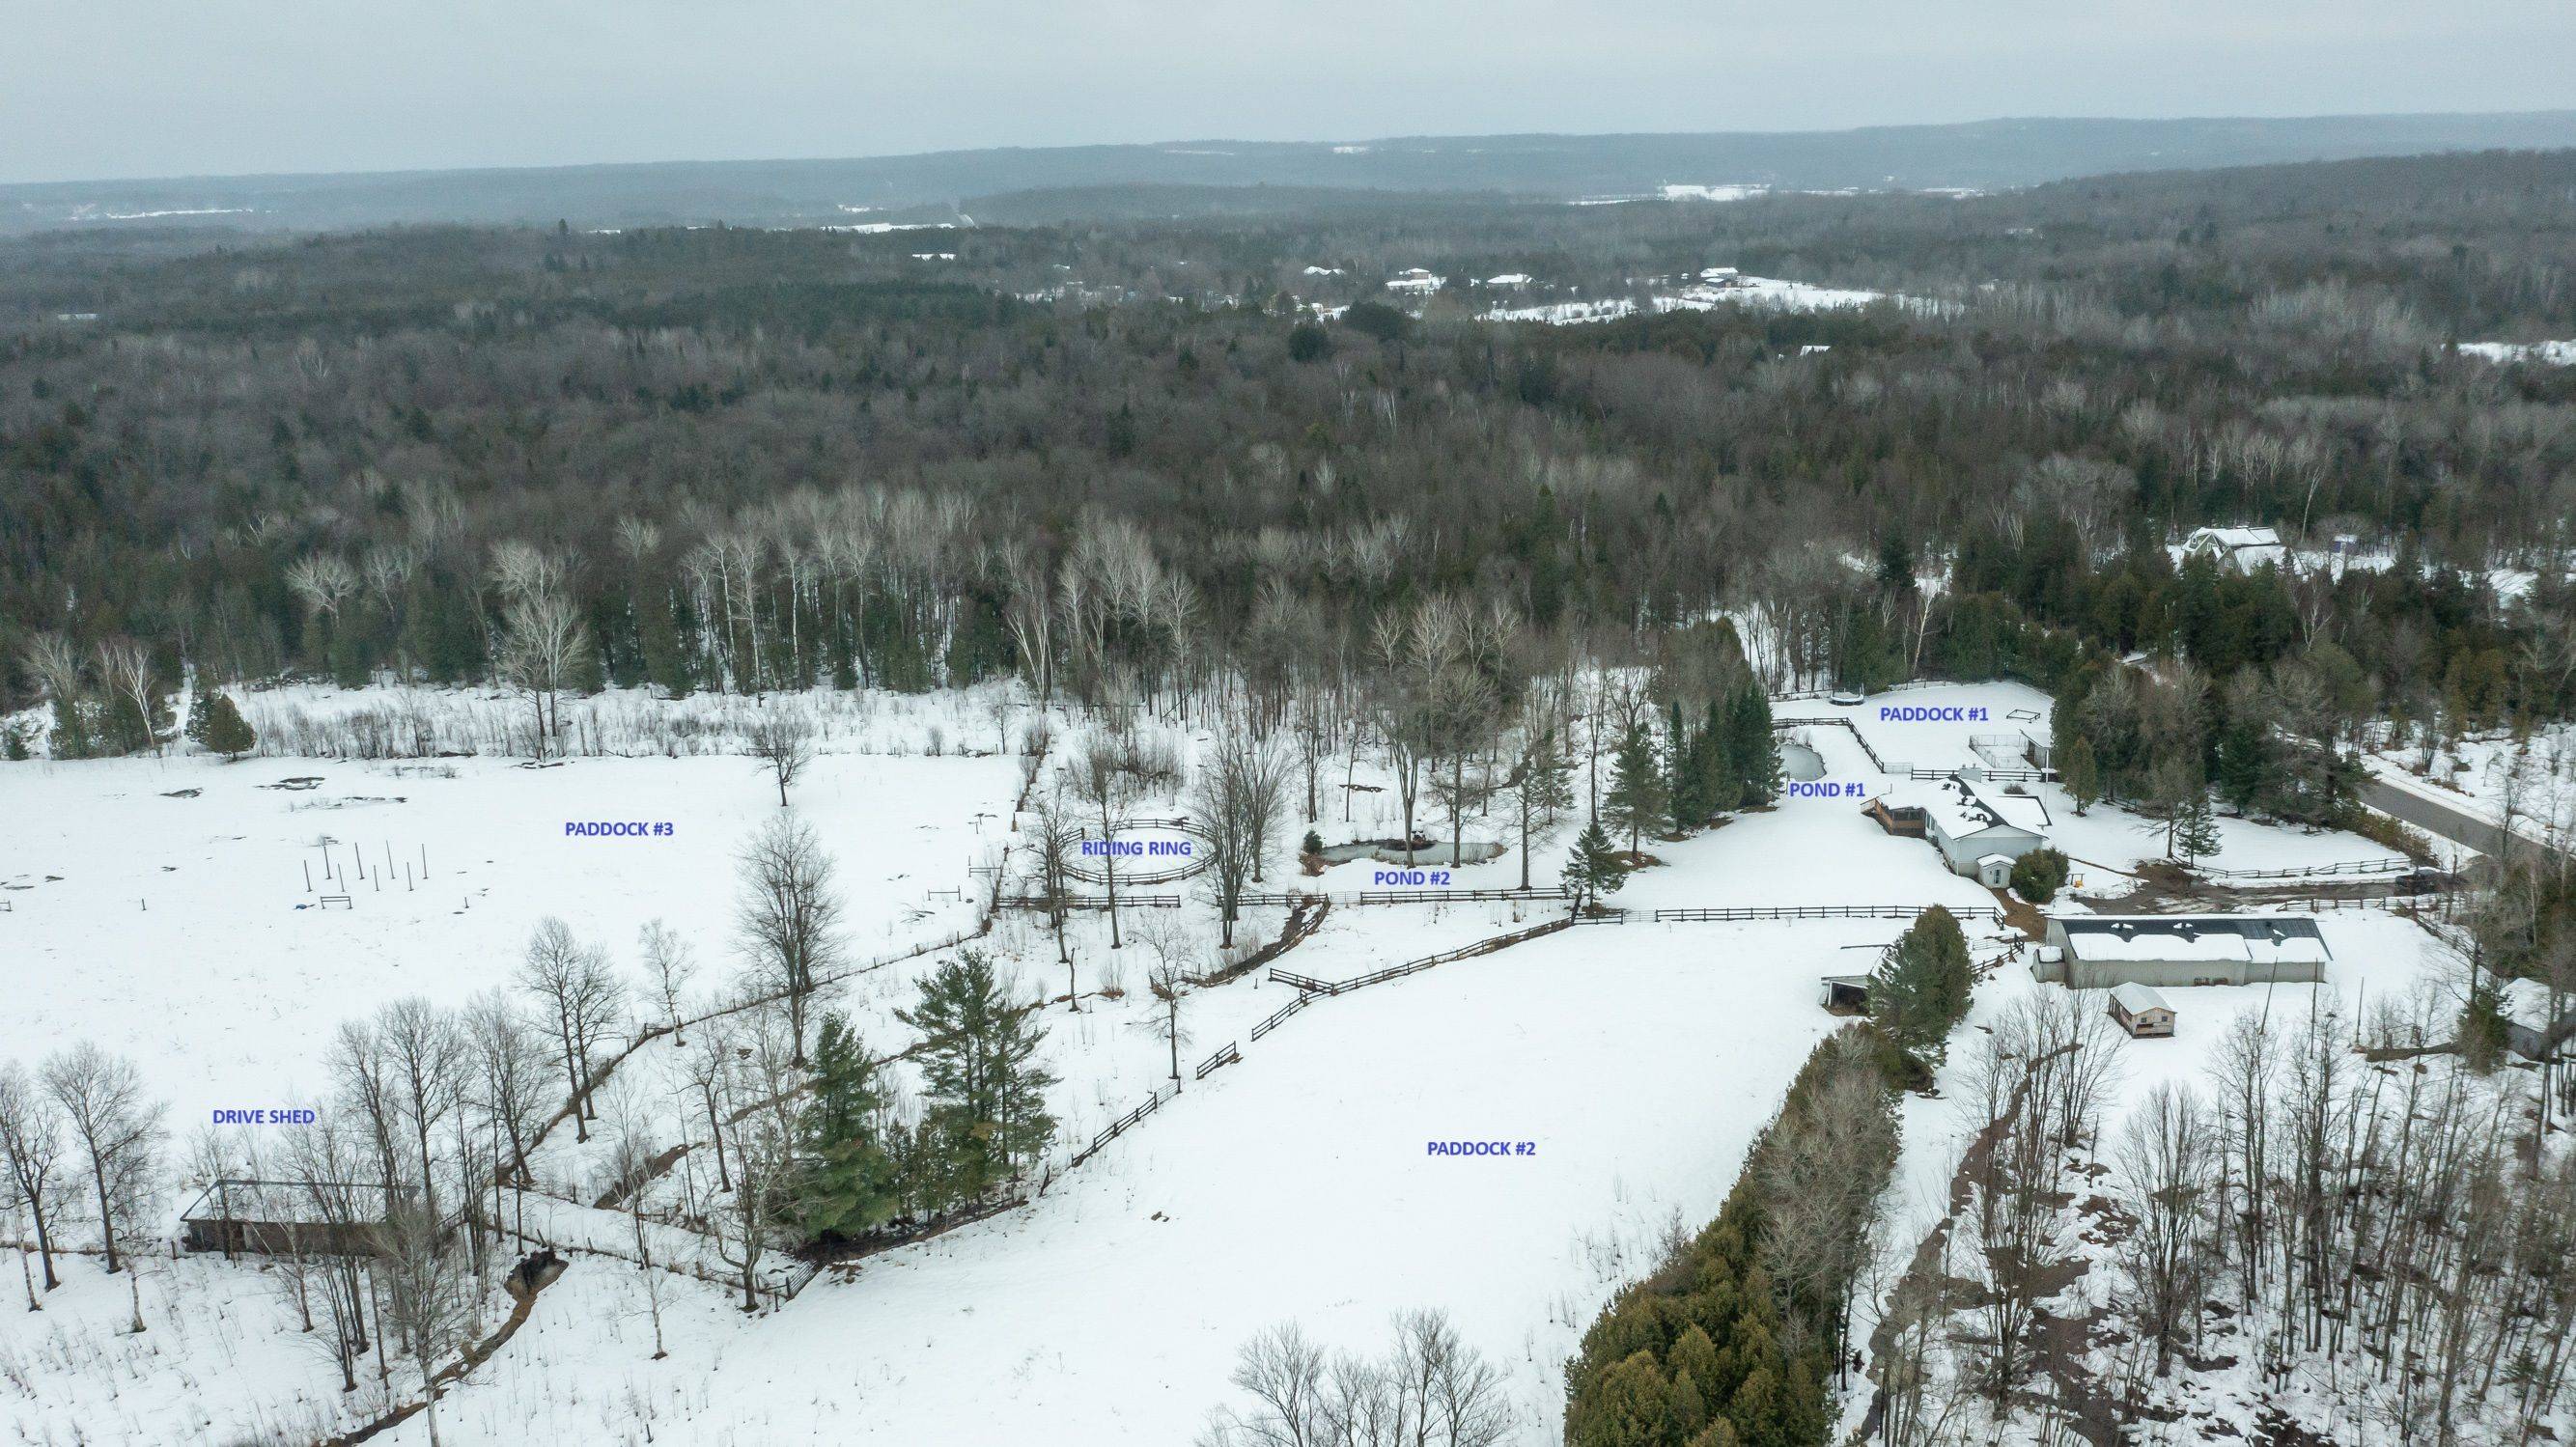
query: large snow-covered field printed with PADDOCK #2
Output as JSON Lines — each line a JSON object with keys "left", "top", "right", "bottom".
{"left": 368, "top": 911, "right": 1898, "bottom": 1444}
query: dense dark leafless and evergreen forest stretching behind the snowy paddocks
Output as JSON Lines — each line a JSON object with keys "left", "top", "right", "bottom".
{"left": 0, "top": 152, "right": 2576, "bottom": 777}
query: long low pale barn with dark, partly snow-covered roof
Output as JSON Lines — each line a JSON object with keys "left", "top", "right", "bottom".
{"left": 2032, "top": 914, "right": 2334, "bottom": 988}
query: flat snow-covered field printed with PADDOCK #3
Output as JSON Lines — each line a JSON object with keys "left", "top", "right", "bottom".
{"left": 0, "top": 755, "right": 1021, "bottom": 1101}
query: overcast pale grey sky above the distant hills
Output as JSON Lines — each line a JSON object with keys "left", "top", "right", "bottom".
{"left": 0, "top": 0, "right": 2576, "bottom": 181}
